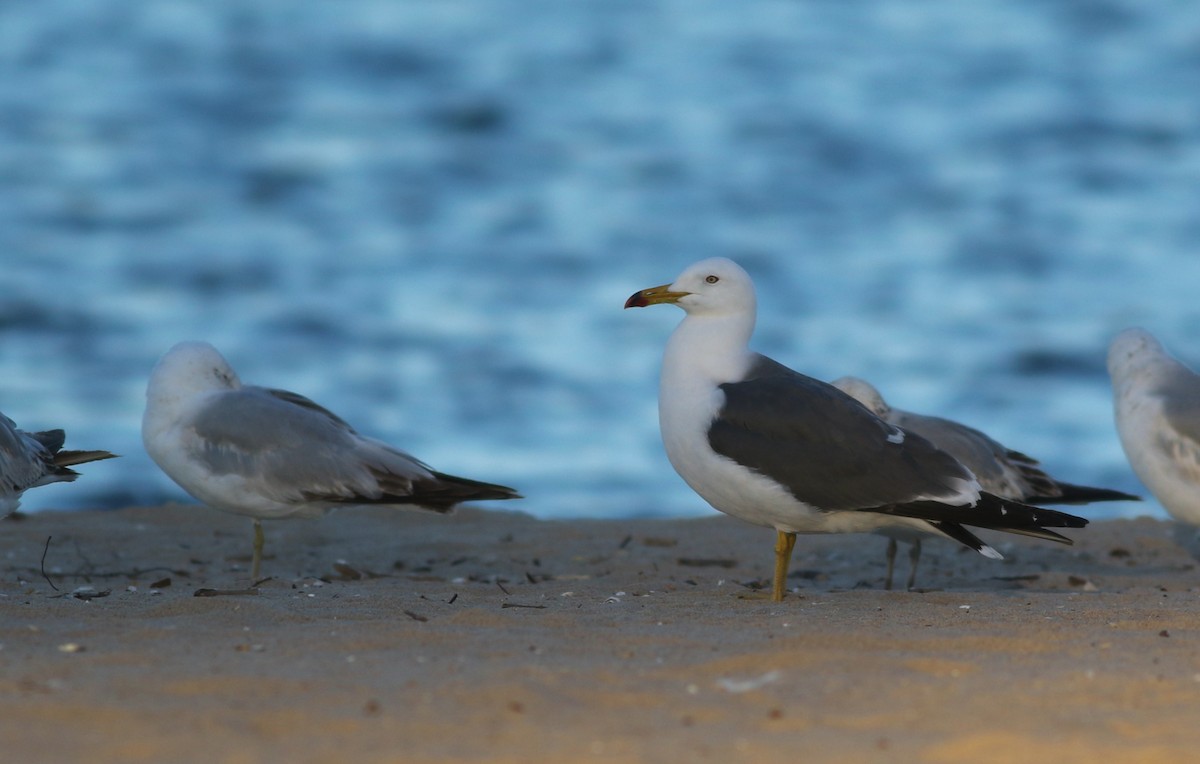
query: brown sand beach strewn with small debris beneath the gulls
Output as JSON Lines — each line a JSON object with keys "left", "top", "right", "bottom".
{"left": 0, "top": 506, "right": 1200, "bottom": 764}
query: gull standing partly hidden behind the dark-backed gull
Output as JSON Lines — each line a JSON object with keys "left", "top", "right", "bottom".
{"left": 830, "top": 377, "right": 1140, "bottom": 589}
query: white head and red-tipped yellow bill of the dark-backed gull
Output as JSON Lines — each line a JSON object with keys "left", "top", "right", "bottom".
{"left": 625, "top": 258, "right": 757, "bottom": 315}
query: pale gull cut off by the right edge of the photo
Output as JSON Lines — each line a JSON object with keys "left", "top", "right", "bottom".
{"left": 1109, "top": 329, "right": 1200, "bottom": 525}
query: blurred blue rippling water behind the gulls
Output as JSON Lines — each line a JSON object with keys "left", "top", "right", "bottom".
{"left": 0, "top": 0, "right": 1200, "bottom": 517}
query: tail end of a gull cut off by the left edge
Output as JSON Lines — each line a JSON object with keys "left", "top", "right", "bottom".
{"left": 0, "top": 414, "right": 116, "bottom": 517}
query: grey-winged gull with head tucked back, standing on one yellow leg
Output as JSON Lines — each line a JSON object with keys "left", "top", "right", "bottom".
{"left": 142, "top": 342, "right": 520, "bottom": 579}
